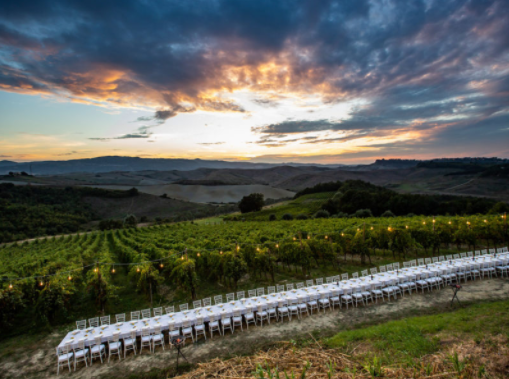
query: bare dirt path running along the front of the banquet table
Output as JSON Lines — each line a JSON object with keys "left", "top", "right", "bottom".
{"left": 0, "top": 278, "right": 509, "bottom": 379}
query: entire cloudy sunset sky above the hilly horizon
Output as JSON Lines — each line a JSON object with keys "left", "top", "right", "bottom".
{"left": 0, "top": 0, "right": 509, "bottom": 164}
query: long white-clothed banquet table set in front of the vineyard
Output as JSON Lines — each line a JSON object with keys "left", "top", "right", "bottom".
{"left": 57, "top": 252, "right": 509, "bottom": 349}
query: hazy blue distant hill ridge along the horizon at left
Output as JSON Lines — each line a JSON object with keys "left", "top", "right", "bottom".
{"left": 0, "top": 156, "right": 338, "bottom": 175}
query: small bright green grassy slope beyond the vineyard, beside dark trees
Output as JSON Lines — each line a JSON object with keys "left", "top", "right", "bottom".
{"left": 237, "top": 192, "right": 335, "bottom": 221}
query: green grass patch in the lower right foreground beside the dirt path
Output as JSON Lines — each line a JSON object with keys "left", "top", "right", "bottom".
{"left": 325, "top": 300, "right": 509, "bottom": 362}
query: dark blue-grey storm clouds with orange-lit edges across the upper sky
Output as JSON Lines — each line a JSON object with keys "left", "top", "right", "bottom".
{"left": 0, "top": 0, "right": 509, "bottom": 154}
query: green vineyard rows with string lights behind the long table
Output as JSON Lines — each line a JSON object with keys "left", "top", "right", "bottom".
{"left": 0, "top": 215, "right": 509, "bottom": 336}
